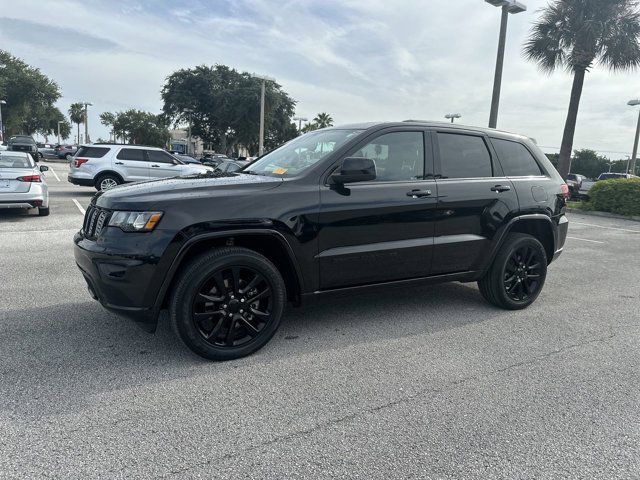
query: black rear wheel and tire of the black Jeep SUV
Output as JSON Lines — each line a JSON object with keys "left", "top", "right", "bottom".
{"left": 478, "top": 233, "right": 547, "bottom": 310}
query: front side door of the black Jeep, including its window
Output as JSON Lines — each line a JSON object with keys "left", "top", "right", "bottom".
{"left": 318, "top": 128, "right": 437, "bottom": 289}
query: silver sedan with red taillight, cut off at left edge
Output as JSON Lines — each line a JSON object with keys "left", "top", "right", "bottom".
{"left": 0, "top": 150, "right": 49, "bottom": 217}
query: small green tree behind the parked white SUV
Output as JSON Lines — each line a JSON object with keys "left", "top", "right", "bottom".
{"left": 100, "top": 108, "right": 169, "bottom": 148}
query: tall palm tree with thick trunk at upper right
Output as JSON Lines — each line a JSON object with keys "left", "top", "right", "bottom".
{"left": 524, "top": 0, "right": 640, "bottom": 178}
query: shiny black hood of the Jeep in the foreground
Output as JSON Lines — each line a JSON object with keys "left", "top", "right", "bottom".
{"left": 94, "top": 172, "right": 282, "bottom": 210}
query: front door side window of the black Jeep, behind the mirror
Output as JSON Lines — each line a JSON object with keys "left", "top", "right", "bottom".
{"left": 351, "top": 132, "right": 424, "bottom": 182}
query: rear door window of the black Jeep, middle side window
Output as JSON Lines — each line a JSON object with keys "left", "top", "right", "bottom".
{"left": 438, "top": 133, "right": 493, "bottom": 178}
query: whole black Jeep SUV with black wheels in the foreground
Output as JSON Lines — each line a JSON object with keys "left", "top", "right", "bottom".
{"left": 74, "top": 121, "right": 568, "bottom": 360}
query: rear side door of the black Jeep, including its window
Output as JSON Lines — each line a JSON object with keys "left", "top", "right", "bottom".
{"left": 432, "top": 128, "right": 518, "bottom": 275}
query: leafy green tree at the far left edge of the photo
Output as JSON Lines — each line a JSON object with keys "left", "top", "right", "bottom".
{"left": 0, "top": 50, "right": 64, "bottom": 135}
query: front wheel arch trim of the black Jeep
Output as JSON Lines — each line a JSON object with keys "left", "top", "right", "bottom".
{"left": 155, "top": 229, "right": 303, "bottom": 311}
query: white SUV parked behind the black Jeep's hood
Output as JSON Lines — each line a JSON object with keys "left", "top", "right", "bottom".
{"left": 67, "top": 144, "right": 213, "bottom": 190}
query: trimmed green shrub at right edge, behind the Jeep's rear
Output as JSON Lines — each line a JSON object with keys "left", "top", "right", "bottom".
{"left": 586, "top": 178, "right": 640, "bottom": 215}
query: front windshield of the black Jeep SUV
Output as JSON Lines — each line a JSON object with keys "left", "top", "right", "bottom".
{"left": 245, "top": 129, "right": 362, "bottom": 177}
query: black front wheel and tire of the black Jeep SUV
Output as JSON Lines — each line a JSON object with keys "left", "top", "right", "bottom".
{"left": 169, "top": 247, "right": 286, "bottom": 361}
